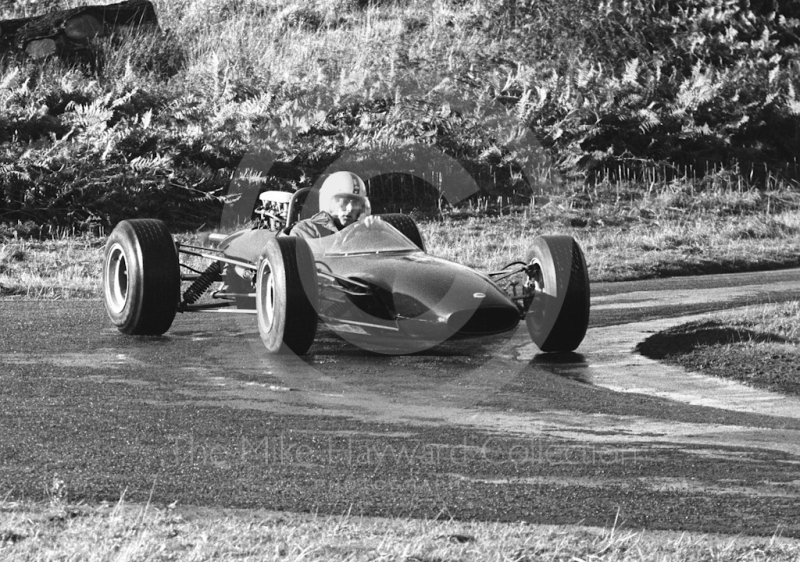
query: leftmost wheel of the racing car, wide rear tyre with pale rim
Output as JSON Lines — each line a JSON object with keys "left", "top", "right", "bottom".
{"left": 103, "top": 219, "right": 181, "bottom": 335}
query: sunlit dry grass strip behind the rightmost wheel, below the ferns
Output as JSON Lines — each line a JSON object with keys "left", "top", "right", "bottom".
{"left": 421, "top": 205, "right": 800, "bottom": 282}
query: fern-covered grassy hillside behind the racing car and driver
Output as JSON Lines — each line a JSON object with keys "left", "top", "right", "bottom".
{"left": 0, "top": 0, "right": 800, "bottom": 229}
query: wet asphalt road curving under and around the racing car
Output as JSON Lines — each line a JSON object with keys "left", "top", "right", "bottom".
{"left": 0, "top": 270, "right": 800, "bottom": 537}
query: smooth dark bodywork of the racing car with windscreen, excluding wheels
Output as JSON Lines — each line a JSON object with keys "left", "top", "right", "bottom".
{"left": 219, "top": 220, "right": 521, "bottom": 351}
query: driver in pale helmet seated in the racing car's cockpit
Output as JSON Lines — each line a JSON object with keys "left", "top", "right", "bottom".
{"left": 290, "top": 172, "right": 376, "bottom": 238}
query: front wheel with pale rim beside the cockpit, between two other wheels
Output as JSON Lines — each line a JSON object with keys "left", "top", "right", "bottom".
{"left": 256, "top": 236, "right": 319, "bottom": 355}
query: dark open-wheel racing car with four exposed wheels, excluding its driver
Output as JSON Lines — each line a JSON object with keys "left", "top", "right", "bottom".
{"left": 103, "top": 188, "right": 589, "bottom": 355}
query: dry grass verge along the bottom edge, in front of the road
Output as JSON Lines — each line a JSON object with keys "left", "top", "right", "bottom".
{"left": 0, "top": 500, "right": 800, "bottom": 562}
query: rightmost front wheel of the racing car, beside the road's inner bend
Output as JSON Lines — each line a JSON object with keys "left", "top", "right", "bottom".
{"left": 525, "top": 236, "right": 589, "bottom": 352}
